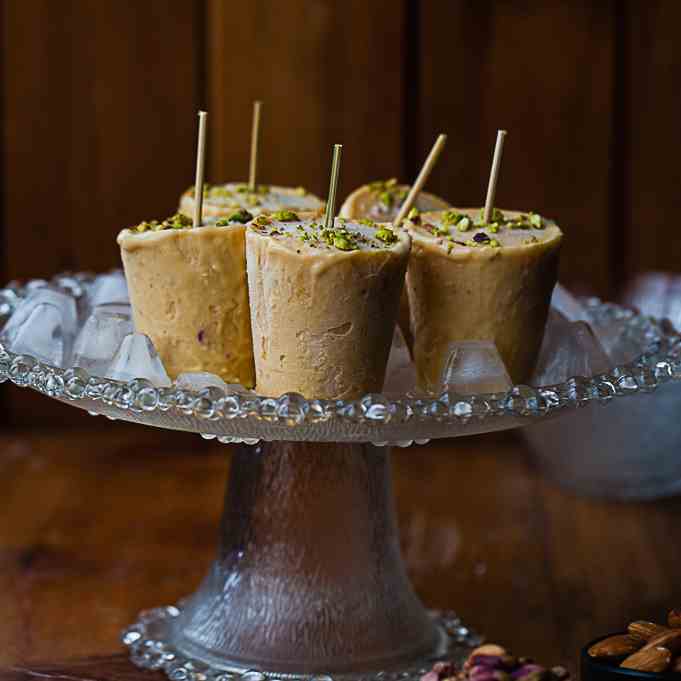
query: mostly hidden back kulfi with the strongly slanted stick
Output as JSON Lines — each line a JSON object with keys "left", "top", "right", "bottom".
{"left": 340, "top": 178, "right": 450, "bottom": 222}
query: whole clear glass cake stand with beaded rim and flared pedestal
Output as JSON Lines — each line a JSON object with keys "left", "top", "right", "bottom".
{"left": 0, "top": 275, "right": 681, "bottom": 681}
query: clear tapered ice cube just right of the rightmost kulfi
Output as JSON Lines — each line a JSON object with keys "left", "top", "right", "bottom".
{"left": 532, "top": 309, "right": 612, "bottom": 385}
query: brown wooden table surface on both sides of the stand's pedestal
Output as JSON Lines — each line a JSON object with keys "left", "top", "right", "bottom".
{"left": 0, "top": 419, "right": 681, "bottom": 681}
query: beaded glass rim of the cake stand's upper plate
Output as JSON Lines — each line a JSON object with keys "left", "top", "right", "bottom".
{"left": 0, "top": 273, "right": 681, "bottom": 446}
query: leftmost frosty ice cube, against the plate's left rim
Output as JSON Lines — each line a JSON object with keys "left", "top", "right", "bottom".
{"left": 0, "top": 287, "right": 77, "bottom": 367}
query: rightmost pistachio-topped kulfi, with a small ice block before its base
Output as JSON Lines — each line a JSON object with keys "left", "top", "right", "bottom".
{"left": 404, "top": 209, "right": 562, "bottom": 390}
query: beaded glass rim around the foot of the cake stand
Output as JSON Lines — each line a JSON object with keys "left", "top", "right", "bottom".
{"left": 121, "top": 603, "right": 483, "bottom": 681}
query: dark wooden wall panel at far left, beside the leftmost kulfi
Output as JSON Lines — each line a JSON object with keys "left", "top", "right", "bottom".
{"left": 3, "top": 0, "right": 201, "bottom": 424}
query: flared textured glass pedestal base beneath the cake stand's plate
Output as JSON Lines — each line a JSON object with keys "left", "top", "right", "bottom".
{"left": 123, "top": 442, "right": 478, "bottom": 681}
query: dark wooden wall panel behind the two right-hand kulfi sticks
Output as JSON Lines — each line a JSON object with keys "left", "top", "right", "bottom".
{"left": 415, "top": 0, "right": 615, "bottom": 294}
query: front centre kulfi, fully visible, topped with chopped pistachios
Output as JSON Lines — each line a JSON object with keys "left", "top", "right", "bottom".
{"left": 246, "top": 216, "right": 410, "bottom": 399}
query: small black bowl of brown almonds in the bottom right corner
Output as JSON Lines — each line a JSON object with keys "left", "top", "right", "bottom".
{"left": 581, "top": 608, "right": 681, "bottom": 681}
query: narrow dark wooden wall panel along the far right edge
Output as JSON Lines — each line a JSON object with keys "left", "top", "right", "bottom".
{"left": 618, "top": 0, "right": 681, "bottom": 273}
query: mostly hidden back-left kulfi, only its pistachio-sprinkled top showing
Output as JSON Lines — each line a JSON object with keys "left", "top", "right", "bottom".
{"left": 178, "top": 182, "right": 324, "bottom": 217}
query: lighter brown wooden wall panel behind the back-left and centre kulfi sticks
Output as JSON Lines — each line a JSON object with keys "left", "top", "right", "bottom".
{"left": 206, "top": 0, "right": 407, "bottom": 200}
